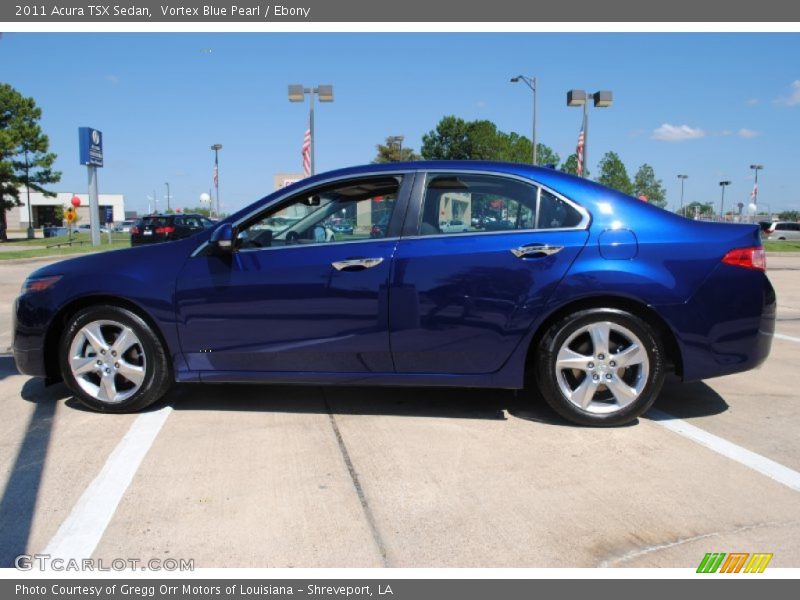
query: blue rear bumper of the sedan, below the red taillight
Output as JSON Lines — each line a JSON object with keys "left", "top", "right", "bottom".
{"left": 655, "top": 264, "right": 776, "bottom": 381}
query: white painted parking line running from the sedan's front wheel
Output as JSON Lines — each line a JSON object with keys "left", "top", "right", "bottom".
{"left": 44, "top": 406, "right": 172, "bottom": 560}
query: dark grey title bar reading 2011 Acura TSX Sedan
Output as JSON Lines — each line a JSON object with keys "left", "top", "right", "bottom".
{"left": 0, "top": 0, "right": 800, "bottom": 23}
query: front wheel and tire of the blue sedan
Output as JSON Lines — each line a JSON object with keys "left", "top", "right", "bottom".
{"left": 59, "top": 305, "right": 172, "bottom": 413}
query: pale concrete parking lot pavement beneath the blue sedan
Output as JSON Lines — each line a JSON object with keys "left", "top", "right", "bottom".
{"left": 0, "top": 256, "right": 800, "bottom": 568}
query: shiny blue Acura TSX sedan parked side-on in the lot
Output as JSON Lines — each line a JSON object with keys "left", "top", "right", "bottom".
{"left": 13, "top": 162, "right": 776, "bottom": 425}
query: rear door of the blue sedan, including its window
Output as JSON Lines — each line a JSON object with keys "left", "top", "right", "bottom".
{"left": 389, "top": 172, "right": 589, "bottom": 374}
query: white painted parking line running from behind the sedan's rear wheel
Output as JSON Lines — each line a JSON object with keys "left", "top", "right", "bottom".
{"left": 647, "top": 409, "right": 800, "bottom": 492}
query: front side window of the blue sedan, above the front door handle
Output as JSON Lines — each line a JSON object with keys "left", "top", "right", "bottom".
{"left": 237, "top": 176, "right": 402, "bottom": 250}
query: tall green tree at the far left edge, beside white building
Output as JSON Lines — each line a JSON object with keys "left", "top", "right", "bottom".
{"left": 0, "top": 83, "right": 61, "bottom": 241}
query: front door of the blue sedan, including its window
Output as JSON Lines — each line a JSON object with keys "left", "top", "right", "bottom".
{"left": 176, "top": 174, "right": 413, "bottom": 379}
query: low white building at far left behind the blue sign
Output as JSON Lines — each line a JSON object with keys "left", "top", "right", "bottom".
{"left": 6, "top": 186, "right": 125, "bottom": 230}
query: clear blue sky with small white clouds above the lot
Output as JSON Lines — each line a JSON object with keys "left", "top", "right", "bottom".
{"left": 0, "top": 33, "right": 800, "bottom": 212}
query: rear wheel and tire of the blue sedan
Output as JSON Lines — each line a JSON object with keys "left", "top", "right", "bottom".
{"left": 535, "top": 308, "right": 664, "bottom": 427}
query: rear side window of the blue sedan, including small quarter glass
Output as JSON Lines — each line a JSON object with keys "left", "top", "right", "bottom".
{"left": 419, "top": 174, "right": 582, "bottom": 235}
